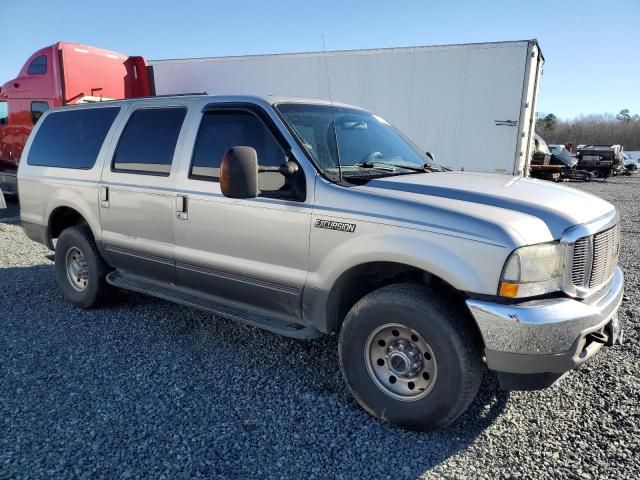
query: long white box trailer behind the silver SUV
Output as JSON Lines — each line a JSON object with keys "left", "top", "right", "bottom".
{"left": 149, "top": 40, "right": 544, "bottom": 175}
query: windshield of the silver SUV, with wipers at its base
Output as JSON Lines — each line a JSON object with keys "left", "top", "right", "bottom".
{"left": 276, "top": 103, "right": 443, "bottom": 179}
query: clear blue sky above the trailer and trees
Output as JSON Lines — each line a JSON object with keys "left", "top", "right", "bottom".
{"left": 0, "top": 0, "right": 640, "bottom": 118}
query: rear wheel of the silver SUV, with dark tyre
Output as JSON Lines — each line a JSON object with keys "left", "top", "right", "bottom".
{"left": 55, "top": 225, "right": 113, "bottom": 308}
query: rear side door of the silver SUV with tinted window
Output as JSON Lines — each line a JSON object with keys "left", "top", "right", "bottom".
{"left": 99, "top": 104, "right": 187, "bottom": 282}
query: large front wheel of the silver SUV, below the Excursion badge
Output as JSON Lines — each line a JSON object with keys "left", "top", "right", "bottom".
{"left": 338, "top": 284, "right": 484, "bottom": 430}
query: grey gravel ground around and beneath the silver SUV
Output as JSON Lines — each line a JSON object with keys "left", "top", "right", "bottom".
{"left": 0, "top": 176, "right": 640, "bottom": 480}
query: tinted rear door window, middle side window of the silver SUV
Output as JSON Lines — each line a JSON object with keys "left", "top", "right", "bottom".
{"left": 112, "top": 107, "right": 187, "bottom": 176}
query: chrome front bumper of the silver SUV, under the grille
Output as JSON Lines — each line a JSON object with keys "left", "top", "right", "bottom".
{"left": 467, "top": 267, "right": 624, "bottom": 386}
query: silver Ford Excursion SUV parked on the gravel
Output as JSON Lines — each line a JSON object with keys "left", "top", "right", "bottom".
{"left": 18, "top": 96, "right": 623, "bottom": 429}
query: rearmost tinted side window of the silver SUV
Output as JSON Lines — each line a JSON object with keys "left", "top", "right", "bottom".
{"left": 27, "top": 107, "right": 120, "bottom": 170}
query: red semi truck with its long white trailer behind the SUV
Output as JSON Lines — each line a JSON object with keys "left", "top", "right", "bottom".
{"left": 0, "top": 40, "right": 544, "bottom": 193}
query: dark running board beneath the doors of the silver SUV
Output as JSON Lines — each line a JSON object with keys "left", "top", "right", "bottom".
{"left": 107, "top": 270, "right": 321, "bottom": 339}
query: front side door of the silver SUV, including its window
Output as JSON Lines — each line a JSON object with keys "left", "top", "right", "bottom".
{"left": 174, "top": 107, "right": 311, "bottom": 316}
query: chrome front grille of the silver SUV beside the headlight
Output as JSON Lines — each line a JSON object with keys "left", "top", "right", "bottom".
{"left": 571, "top": 225, "right": 620, "bottom": 288}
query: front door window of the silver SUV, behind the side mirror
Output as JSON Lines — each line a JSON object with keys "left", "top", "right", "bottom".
{"left": 189, "top": 111, "right": 285, "bottom": 190}
